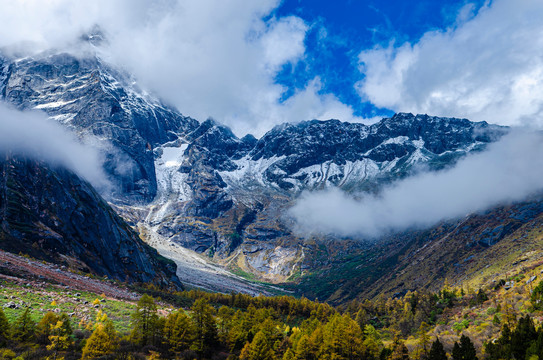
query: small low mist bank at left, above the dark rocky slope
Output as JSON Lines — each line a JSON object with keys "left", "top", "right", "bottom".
{"left": 0, "top": 103, "right": 110, "bottom": 191}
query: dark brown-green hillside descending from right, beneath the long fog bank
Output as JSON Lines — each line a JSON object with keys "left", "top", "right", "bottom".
{"left": 291, "top": 201, "right": 543, "bottom": 304}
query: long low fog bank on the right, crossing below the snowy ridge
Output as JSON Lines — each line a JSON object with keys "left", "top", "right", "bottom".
{"left": 290, "top": 130, "right": 543, "bottom": 237}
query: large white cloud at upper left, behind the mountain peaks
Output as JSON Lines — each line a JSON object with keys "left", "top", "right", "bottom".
{"left": 0, "top": 0, "right": 366, "bottom": 135}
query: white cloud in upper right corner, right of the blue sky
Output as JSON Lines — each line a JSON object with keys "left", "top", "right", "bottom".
{"left": 357, "top": 0, "right": 543, "bottom": 126}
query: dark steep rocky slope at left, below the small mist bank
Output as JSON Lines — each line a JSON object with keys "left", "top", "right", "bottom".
{"left": 0, "top": 156, "right": 181, "bottom": 288}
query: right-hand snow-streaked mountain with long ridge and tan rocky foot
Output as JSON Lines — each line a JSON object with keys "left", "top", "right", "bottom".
{"left": 144, "top": 114, "right": 506, "bottom": 281}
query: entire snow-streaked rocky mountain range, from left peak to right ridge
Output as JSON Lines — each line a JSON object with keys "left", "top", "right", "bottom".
{"left": 0, "top": 45, "right": 506, "bottom": 292}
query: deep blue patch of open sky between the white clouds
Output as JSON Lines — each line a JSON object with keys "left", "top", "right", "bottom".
{"left": 273, "top": 0, "right": 484, "bottom": 118}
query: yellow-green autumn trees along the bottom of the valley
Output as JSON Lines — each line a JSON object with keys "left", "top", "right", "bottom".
{"left": 0, "top": 287, "right": 543, "bottom": 360}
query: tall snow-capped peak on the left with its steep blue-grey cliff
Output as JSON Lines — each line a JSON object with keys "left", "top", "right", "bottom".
{"left": 0, "top": 52, "right": 197, "bottom": 203}
